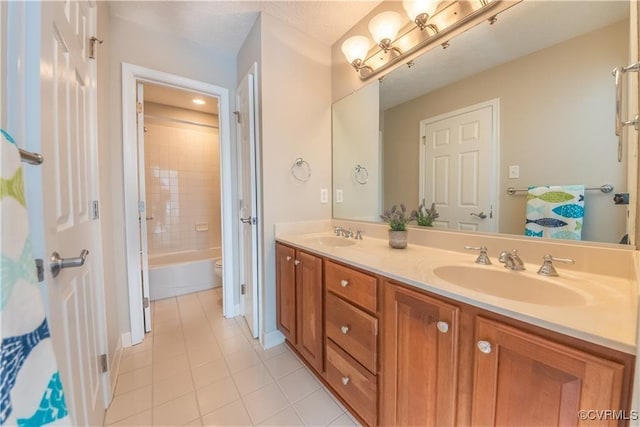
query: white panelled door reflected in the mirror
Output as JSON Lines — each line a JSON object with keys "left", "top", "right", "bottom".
{"left": 420, "top": 100, "right": 497, "bottom": 231}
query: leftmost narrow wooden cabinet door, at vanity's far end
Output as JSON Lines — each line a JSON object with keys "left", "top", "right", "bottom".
{"left": 276, "top": 243, "right": 296, "bottom": 344}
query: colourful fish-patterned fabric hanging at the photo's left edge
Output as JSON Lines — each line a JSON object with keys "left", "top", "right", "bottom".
{"left": 0, "top": 129, "right": 71, "bottom": 426}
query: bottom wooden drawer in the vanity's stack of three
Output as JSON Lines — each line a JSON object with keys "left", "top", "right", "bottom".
{"left": 326, "top": 341, "right": 377, "bottom": 426}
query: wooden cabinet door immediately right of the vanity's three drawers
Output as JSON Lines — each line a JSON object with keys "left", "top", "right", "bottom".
{"left": 380, "top": 282, "right": 459, "bottom": 427}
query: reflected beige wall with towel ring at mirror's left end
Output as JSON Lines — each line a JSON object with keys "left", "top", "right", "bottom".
{"left": 332, "top": 80, "right": 382, "bottom": 221}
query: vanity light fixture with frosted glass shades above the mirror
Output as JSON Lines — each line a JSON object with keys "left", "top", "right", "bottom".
{"left": 342, "top": 0, "right": 522, "bottom": 80}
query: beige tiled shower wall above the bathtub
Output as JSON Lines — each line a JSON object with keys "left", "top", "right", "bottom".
{"left": 145, "top": 110, "right": 222, "bottom": 255}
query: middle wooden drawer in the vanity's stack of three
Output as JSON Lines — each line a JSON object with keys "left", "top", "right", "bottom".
{"left": 325, "top": 292, "right": 378, "bottom": 373}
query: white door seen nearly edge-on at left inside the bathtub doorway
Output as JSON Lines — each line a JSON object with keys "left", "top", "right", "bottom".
{"left": 136, "top": 83, "right": 153, "bottom": 332}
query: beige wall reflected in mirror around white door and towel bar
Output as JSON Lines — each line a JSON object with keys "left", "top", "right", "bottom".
{"left": 383, "top": 22, "right": 628, "bottom": 243}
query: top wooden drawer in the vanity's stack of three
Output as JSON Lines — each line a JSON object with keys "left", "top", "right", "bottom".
{"left": 324, "top": 261, "right": 378, "bottom": 313}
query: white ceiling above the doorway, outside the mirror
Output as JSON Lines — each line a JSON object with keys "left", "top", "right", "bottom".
{"left": 110, "top": 0, "right": 380, "bottom": 54}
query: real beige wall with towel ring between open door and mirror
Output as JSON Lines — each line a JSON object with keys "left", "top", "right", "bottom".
{"left": 261, "top": 14, "right": 331, "bottom": 334}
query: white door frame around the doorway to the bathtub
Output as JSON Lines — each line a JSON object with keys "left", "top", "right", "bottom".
{"left": 122, "top": 63, "right": 237, "bottom": 346}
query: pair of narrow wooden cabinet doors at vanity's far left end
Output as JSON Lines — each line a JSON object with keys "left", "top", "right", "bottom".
{"left": 276, "top": 243, "right": 324, "bottom": 373}
